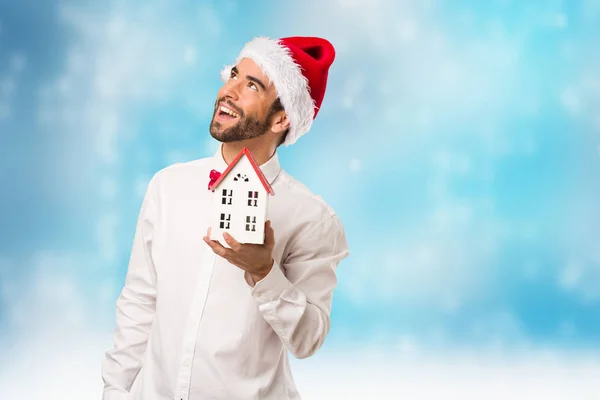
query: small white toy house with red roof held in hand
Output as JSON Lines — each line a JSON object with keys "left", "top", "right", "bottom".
{"left": 209, "top": 148, "right": 275, "bottom": 247}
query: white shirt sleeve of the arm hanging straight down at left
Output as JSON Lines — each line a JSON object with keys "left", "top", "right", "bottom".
{"left": 102, "top": 175, "right": 156, "bottom": 400}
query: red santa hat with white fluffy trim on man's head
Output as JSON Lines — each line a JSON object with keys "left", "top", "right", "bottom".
{"left": 221, "top": 36, "right": 335, "bottom": 146}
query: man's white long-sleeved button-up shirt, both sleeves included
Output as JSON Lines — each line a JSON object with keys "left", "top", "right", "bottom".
{"left": 102, "top": 146, "right": 349, "bottom": 400}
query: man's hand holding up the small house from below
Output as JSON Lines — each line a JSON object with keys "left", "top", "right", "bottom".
{"left": 203, "top": 221, "right": 275, "bottom": 283}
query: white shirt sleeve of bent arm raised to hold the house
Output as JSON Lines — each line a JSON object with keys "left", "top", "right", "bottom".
{"left": 252, "top": 215, "right": 349, "bottom": 358}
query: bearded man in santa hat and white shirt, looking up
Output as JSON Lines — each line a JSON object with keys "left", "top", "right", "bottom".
{"left": 102, "top": 37, "right": 349, "bottom": 400}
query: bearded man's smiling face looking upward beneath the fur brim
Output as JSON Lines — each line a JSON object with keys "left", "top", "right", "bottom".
{"left": 210, "top": 58, "right": 276, "bottom": 142}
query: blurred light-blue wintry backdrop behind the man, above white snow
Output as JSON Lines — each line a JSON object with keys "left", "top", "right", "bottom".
{"left": 0, "top": 0, "right": 600, "bottom": 397}
